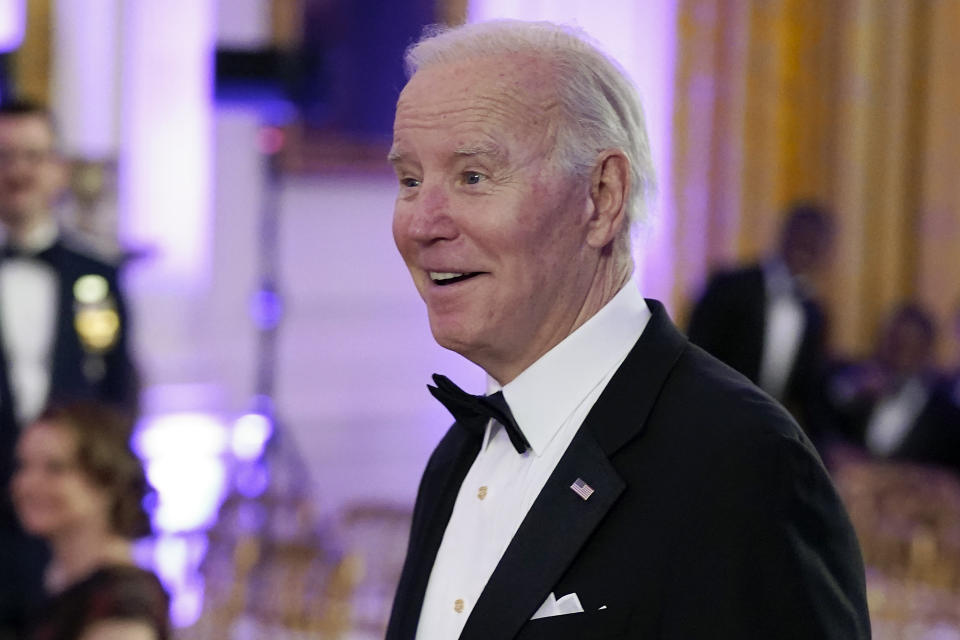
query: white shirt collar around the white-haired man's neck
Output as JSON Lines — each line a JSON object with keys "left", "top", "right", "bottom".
{"left": 483, "top": 280, "right": 650, "bottom": 456}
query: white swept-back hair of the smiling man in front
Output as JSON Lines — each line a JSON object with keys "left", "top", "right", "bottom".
{"left": 405, "top": 20, "right": 656, "bottom": 229}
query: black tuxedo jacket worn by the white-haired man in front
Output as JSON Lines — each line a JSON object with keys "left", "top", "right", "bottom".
{"left": 387, "top": 301, "right": 870, "bottom": 640}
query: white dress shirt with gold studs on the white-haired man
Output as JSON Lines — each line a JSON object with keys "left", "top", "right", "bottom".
{"left": 416, "top": 281, "right": 650, "bottom": 640}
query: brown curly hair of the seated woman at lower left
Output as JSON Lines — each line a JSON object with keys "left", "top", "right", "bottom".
{"left": 36, "top": 401, "right": 152, "bottom": 539}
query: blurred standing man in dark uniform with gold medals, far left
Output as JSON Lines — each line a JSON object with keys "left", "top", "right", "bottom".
{"left": 0, "top": 102, "right": 137, "bottom": 638}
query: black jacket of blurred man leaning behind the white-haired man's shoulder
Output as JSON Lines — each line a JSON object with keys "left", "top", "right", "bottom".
{"left": 687, "top": 264, "right": 826, "bottom": 437}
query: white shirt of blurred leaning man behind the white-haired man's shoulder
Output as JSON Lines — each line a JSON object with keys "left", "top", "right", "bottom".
{"left": 758, "top": 261, "right": 806, "bottom": 400}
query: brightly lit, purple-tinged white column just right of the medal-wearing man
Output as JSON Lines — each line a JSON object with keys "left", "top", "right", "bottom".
{"left": 118, "top": 0, "right": 215, "bottom": 292}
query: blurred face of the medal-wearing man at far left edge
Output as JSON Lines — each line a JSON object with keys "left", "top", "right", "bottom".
{"left": 0, "top": 114, "right": 65, "bottom": 229}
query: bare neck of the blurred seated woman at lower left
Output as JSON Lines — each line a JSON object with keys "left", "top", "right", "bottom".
{"left": 46, "top": 529, "right": 133, "bottom": 592}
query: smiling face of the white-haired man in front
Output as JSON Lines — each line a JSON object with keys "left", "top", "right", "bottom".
{"left": 391, "top": 58, "right": 596, "bottom": 384}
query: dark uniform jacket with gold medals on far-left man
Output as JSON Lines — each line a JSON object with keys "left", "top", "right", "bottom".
{"left": 0, "top": 238, "right": 138, "bottom": 635}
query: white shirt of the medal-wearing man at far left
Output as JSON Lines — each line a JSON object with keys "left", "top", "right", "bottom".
{"left": 0, "top": 222, "right": 58, "bottom": 424}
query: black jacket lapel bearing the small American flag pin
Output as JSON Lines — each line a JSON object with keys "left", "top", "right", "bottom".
{"left": 460, "top": 300, "right": 688, "bottom": 640}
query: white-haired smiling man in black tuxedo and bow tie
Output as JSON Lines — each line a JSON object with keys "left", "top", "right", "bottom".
{"left": 387, "top": 21, "right": 870, "bottom": 640}
